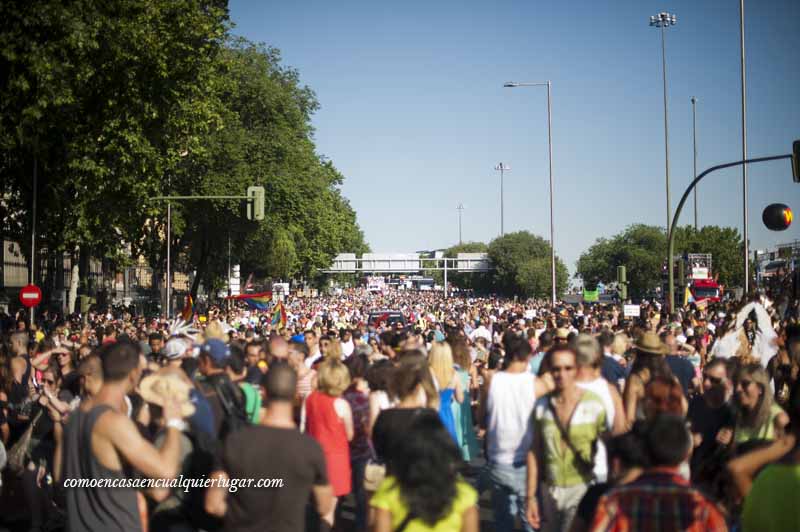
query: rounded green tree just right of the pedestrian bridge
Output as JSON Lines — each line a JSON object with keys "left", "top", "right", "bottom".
{"left": 488, "top": 231, "right": 569, "bottom": 298}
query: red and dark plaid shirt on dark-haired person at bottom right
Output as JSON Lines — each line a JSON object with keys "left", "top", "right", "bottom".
{"left": 592, "top": 468, "right": 728, "bottom": 532}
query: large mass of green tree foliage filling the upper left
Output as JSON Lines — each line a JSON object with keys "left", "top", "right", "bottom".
{"left": 0, "top": 0, "right": 368, "bottom": 304}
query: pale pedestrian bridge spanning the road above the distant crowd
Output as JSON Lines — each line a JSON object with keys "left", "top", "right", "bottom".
{"left": 322, "top": 251, "right": 492, "bottom": 273}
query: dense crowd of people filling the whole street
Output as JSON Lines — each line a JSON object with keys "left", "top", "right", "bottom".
{"left": 0, "top": 289, "right": 800, "bottom": 532}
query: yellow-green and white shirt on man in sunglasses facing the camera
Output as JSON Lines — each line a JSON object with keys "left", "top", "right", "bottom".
{"left": 533, "top": 390, "right": 606, "bottom": 488}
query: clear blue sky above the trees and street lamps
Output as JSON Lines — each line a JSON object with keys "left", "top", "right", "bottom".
{"left": 230, "top": 0, "right": 800, "bottom": 273}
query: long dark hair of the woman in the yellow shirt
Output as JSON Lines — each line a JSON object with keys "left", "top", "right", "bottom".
{"left": 394, "top": 409, "right": 461, "bottom": 526}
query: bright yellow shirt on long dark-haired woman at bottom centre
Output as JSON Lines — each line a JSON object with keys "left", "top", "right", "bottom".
{"left": 370, "top": 477, "right": 478, "bottom": 532}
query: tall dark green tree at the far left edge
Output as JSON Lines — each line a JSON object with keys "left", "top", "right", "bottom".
{"left": 0, "top": 0, "right": 227, "bottom": 310}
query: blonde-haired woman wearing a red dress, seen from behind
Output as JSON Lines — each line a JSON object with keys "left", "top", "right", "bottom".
{"left": 305, "top": 358, "right": 355, "bottom": 526}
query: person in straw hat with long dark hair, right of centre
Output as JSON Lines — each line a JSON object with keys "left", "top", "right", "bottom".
{"left": 622, "top": 331, "right": 673, "bottom": 425}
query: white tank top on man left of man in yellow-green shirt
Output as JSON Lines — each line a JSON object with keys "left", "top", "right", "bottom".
{"left": 486, "top": 371, "right": 536, "bottom": 465}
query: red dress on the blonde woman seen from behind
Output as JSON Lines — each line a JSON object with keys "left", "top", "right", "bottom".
{"left": 306, "top": 390, "right": 352, "bottom": 497}
